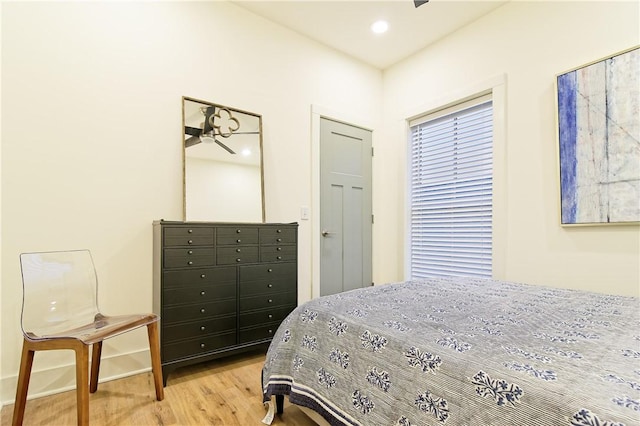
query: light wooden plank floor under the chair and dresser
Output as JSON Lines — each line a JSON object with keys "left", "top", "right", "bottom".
{"left": 0, "top": 352, "right": 315, "bottom": 426}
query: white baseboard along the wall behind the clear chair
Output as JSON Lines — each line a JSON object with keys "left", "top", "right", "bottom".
{"left": 0, "top": 349, "right": 151, "bottom": 406}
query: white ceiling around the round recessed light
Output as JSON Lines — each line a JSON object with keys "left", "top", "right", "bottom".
{"left": 232, "top": 0, "right": 508, "bottom": 69}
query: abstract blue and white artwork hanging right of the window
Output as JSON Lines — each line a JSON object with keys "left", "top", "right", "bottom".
{"left": 557, "top": 48, "right": 640, "bottom": 225}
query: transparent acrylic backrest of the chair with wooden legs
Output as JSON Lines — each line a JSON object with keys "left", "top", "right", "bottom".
{"left": 20, "top": 250, "right": 99, "bottom": 337}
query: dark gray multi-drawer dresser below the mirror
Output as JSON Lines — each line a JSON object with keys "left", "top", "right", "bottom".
{"left": 153, "top": 220, "right": 298, "bottom": 385}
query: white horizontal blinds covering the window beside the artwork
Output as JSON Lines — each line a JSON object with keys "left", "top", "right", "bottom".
{"left": 410, "top": 98, "right": 493, "bottom": 278}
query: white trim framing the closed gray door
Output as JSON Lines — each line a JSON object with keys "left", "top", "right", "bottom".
{"left": 309, "top": 104, "right": 375, "bottom": 299}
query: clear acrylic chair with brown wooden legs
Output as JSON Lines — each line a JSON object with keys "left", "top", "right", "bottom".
{"left": 13, "top": 250, "right": 164, "bottom": 426}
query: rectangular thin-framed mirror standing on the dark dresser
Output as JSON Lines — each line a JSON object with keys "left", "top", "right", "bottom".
{"left": 182, "top": 96, "right": 264, "bottom": 222}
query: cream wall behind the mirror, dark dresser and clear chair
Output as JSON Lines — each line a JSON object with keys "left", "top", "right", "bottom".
{"left": 0, "top": 2, "right": 382, "bottom": 402}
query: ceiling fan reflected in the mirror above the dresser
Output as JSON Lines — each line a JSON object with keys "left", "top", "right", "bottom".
{"left": 184, "top": 106, "right": 259, "bottom": 154}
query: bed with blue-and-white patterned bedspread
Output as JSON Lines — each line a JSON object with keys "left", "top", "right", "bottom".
{"left": 262, "top": 278, "right": 640, "bottom": 426}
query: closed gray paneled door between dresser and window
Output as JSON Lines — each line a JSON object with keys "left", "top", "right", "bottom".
{"left": 320, "top": 118, "right": 372, "bottom": 296}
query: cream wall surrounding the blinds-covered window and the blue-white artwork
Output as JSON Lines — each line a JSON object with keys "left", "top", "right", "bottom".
{"left": 374, "top": 1, "right": 640, "bottom": 296}
